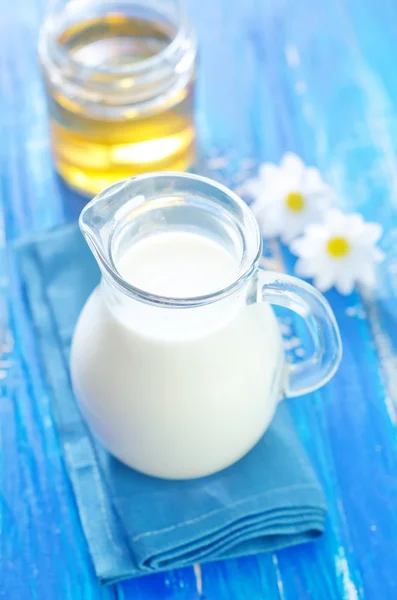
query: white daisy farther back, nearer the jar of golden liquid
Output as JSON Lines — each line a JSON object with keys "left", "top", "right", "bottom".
{"left": 243, "top": 152, "right": 333, "bottom": 243}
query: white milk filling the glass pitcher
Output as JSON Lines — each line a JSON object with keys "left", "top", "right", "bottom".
{"left": 71, "top": 233, "right": 283, "bottom": 478}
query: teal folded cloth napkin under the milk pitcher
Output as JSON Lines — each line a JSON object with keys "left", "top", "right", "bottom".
{"left": 16, "top": 225, "right": 325, "bottom": 584}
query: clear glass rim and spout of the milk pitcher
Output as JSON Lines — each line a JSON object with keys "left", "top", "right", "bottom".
{"left": 79, "top": 172, "right": 262, "bottom": 308}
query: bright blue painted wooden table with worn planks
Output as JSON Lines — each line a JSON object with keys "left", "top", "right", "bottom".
{"left": 0, "top": 0, "right": 397, "bottom": 600}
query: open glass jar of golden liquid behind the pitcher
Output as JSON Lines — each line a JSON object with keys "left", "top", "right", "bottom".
{"left": 39, "top": 0, "right": 196, "bottom": 195}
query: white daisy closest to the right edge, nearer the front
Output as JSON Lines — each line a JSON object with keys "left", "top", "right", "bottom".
{"left": 290, "top": 209, "right": 384, "bottom": 295}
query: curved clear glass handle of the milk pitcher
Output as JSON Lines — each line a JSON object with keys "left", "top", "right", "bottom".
{"left": 257, "top": 269, "right": 342, "bottom": 397}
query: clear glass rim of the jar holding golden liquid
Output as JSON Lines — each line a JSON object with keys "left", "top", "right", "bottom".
{"left": 39, "top": 4, "right": 196, "bottom": 76}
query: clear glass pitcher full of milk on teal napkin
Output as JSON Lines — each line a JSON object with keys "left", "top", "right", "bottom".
{"left": 71, "top": 173, "right": 342, "bottom": 479}
